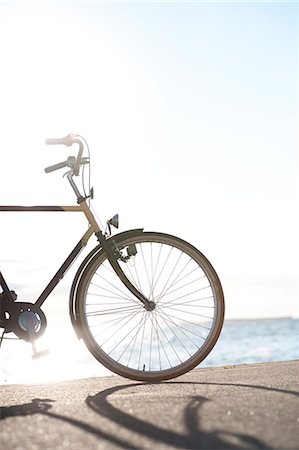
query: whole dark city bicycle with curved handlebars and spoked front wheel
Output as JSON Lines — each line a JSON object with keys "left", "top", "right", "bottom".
{"left": 0, "top": 134, "right": 224, "bottom": 382}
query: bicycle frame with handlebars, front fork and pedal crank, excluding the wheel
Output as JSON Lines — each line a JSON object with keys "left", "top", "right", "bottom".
{"left": 0, "top": 135, "right": 155, "bottom": 355}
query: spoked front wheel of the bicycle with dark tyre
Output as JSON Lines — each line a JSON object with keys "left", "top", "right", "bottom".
{"left": 77, "top": 232, "right": 224, "bottom": 381}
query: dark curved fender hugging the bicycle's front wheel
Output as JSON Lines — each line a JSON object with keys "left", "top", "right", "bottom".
{"left": 69, "top": 228, "right": 143, "bottom": 339}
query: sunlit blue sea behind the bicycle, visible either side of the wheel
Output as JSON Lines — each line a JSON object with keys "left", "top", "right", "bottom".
{"left": 0, "top": 318, "right": 299, "bottom": 384}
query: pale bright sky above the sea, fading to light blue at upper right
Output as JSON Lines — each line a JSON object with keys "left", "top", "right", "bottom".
{"left": 0, "top": 1, "right": 299, "bottom": 328}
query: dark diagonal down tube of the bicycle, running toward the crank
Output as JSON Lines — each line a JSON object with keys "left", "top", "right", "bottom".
{"left": 35, "top": 227, "right": 94, "bottom": 308}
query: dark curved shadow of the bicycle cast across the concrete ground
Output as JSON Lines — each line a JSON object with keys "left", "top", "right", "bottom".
{"left": 0, "top": 381, "right": 299, "bottom": 450}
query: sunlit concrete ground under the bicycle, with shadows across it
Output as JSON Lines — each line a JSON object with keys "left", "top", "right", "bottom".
{"left": 0, "top": 361, "right": 299, "bottom": 450}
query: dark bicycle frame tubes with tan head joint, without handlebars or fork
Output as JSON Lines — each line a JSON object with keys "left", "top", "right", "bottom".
{"left": 0, "top": 200, "right": 101, "bottom": 308}
